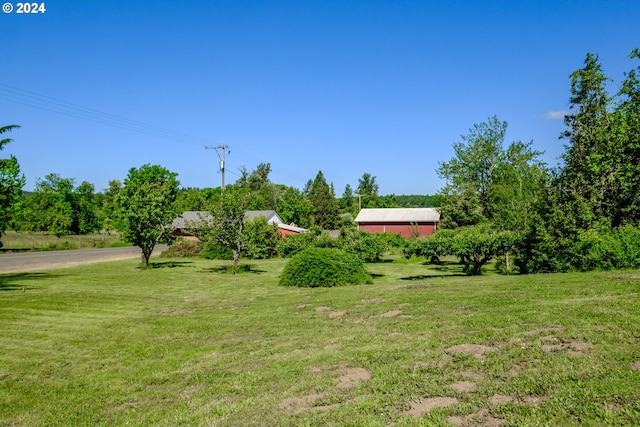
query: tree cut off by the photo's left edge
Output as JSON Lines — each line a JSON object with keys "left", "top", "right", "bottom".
{"left": 0, "top": 125, "right": 25, "bottom": 236}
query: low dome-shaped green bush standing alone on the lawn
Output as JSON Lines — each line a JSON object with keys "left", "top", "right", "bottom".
{"left": 280, "top": 248, "right": 372, "bottom": 288}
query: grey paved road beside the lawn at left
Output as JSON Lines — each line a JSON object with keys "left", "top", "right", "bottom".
{"left": 0, "top": 245, "right": 167, "bottom": 274}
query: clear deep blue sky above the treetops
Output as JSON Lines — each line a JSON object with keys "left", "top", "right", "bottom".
{"left": 0, "top": 0, "right": 640, "bottom": 196}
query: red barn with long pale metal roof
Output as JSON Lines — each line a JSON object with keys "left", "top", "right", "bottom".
{"left": 355, "top": 208, "right": 440, "bottom": 237}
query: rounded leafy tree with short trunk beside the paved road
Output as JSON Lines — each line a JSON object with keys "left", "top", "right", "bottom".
{"left": 115, "top": 164, "right": 179, "bottom": 268}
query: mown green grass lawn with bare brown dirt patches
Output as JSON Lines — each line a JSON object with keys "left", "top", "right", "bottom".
{"left": 0, "top": 258, "right": 640, "bottom": 426}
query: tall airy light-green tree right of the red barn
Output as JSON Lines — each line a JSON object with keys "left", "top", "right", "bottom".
{"left": 437, "top": 116, "right": 546, "bottom": 229}
